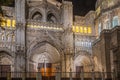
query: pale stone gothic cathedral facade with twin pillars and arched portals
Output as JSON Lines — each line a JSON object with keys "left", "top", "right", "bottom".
{"left": 0, "top": 0, "right": 94, "bottom": 72}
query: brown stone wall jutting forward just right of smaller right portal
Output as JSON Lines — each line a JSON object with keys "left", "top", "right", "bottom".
{"left": 93, "top": 30, "right": 111, "bottom": 72}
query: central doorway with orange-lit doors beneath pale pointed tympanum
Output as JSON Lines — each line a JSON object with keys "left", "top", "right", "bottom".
{"left": 37, "top": 54, "right": 55, "bottom": 80}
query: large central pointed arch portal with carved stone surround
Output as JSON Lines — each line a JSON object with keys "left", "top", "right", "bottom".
{"left": 29, "top": 42, "right": 60, "bottom": 75}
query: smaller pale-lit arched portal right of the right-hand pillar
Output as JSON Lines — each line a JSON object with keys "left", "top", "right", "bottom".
{"left": 74, "top": 51, "right": 93, "bottom": 72}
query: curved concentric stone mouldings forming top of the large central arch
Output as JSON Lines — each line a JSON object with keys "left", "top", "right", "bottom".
{"left": 29, "top": 42, "right": 60, "bottom": 63}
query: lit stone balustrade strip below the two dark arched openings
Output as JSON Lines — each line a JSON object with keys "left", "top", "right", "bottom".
{"left": 27, "top": 20, "right": 63, "bottom": 31}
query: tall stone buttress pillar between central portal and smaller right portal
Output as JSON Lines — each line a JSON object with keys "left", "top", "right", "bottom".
{"left": 62, "top": 1, "right": 73, "bottom": 74}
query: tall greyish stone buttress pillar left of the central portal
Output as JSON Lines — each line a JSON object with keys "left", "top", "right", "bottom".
{"left": 15, "top": 0, "right": 27, "bottom": 72}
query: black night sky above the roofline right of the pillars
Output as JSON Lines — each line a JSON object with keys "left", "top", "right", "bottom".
{"left": 58, "top": 0, "right": 97, "bottom": 16}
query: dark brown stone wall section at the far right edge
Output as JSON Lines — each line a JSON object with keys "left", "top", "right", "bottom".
{"left": 110, "top": 26, "right": 120, "bottom": 76}
